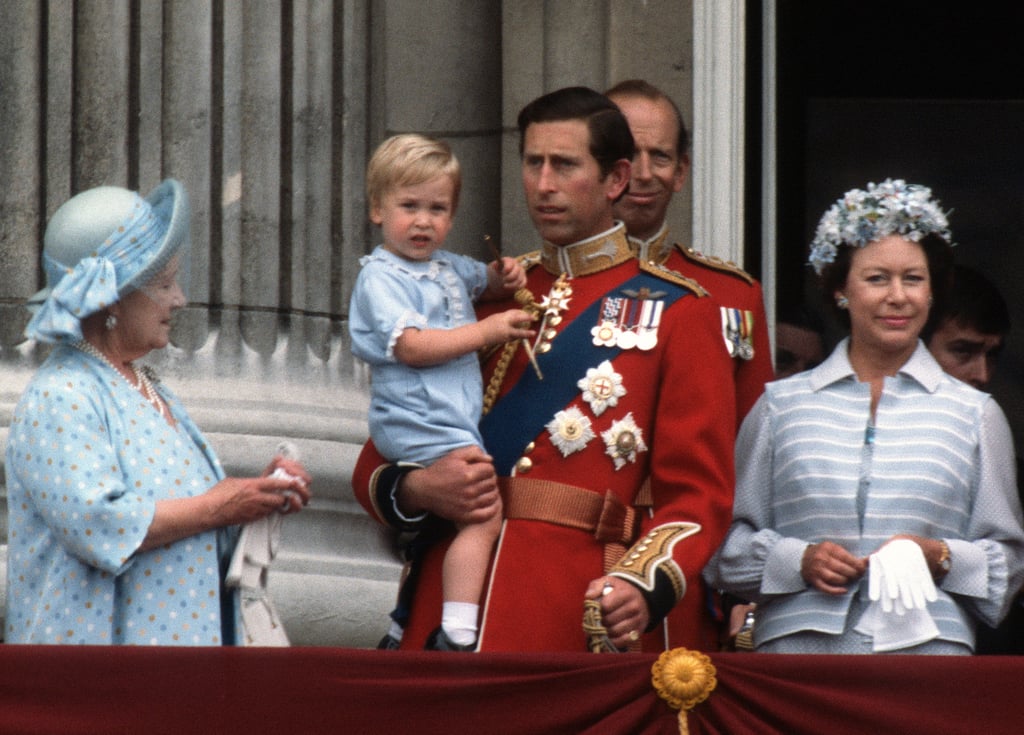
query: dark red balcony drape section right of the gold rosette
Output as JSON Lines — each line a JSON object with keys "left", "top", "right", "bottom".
{"left": 690, "top": 653, "right": 1024, "bottom": 735}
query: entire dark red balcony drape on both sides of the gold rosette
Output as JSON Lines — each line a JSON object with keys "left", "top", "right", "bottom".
{"left": 0, "top": 645, "right": 1024, "bottom": 735}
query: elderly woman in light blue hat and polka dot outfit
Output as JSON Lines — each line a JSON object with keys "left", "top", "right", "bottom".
{"left": 4, "top": 179, "right": 309, "bottom": 646}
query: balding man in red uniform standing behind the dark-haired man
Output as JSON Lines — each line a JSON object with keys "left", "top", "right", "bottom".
{"left": 605, "top": 79, "right": 774, "bottom": 431}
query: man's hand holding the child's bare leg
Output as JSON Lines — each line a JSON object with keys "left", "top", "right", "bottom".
{"left": 398, "top": 446, "right": 501, "bottom": 524}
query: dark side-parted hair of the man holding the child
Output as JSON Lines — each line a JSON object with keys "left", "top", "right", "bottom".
{"left": 517, "top": 87, "right": 635, "bottom": 177}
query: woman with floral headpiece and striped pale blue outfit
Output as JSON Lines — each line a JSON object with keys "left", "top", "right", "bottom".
{"left": 706, "top": 180, "right": 1024, "bottom": 654}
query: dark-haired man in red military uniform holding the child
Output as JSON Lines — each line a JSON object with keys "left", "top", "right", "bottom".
{"left": 353, "top": 87, "right": 735, "bottom": 651}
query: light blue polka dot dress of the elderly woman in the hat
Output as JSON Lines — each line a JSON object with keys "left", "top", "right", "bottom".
{"left": 4, "top": 345, "right": 237, "bottom": 646}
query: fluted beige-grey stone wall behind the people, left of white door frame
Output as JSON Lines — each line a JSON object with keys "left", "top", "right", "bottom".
{"left": 0, "top": 0, "right": 704, "bottom": 646}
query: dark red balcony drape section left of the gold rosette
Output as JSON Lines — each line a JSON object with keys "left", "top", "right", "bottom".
{"left": 0, "top": 645, "right": 678, "bottom": 735}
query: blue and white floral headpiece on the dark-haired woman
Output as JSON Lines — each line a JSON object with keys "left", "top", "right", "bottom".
{"left": 808, "top": 179, "right": 952, "bottom": 275}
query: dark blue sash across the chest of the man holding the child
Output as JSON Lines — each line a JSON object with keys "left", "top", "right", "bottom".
{"left": 480, "top": 273, "right": 692, "bottom": 476}
